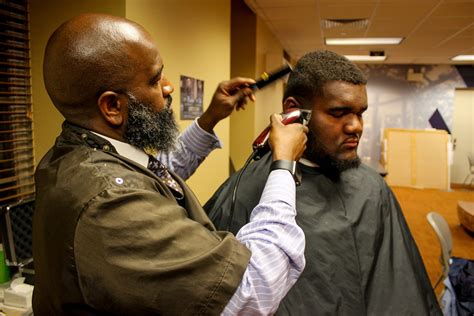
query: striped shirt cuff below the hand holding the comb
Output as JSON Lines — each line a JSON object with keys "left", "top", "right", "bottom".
{"left": 180, "top": 119, "right": 222, "bottom": 157}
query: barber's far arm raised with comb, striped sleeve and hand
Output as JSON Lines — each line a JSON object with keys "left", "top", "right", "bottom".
{"left": 158, "top": 77, "right": 255, "bottom": 180}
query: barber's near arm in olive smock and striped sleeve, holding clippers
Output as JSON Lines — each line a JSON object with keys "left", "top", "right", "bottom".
{"left": 74, "top": 115, "right": 305, "bottom": 315}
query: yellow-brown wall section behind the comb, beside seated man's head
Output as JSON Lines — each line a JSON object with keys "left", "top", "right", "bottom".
{"left": 230, "top": 0, "right": 283, "bottom": 170}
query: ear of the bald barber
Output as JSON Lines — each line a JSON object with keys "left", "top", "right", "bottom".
{"left": 97, "top": 91, "right": 128, "bottom": 127}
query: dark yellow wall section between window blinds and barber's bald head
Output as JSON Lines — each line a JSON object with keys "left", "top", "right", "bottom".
{"left": 30, "top": 0, "right": 125, "bottom": 163}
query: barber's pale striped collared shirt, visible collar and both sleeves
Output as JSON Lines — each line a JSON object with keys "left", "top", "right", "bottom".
{"left": 99, "top": 120, "right": 305, "bottom": 315}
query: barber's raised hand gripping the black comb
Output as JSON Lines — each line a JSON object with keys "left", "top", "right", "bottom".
{"left": 198, "top": 77, "right": 255, "bottom": 132}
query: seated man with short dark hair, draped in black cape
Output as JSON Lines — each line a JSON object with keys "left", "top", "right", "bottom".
{"left": 204, "top": 51, "right": 440, "bottom": 315}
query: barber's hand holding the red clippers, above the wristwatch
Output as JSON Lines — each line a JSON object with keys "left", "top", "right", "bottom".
{"left": 269, "top": 114, "right": 308, "bottom": 161}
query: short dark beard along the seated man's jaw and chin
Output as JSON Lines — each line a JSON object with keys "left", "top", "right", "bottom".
{"left": 305, "top": 131, "right": 361, "bottom": 179}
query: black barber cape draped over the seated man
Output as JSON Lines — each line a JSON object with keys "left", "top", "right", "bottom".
{"left": 204, "top": 154, "right": 441, "bottom": 316}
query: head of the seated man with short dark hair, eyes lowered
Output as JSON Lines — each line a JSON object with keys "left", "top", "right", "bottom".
{"left": 283, "top": 51, "right": 367, "bottom": 173}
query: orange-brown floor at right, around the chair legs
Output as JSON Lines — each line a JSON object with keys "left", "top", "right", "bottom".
{"left": 392, "top": 187, "right": 474, "bottom": 292}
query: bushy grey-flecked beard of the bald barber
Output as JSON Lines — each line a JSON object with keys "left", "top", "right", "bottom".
{"left": 124, "top": 93, "right": 179, "bottom": 152}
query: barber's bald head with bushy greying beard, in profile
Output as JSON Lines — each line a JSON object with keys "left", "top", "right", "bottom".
{"left": 43, "top": 14, "right": 178, "bottom": 150}
